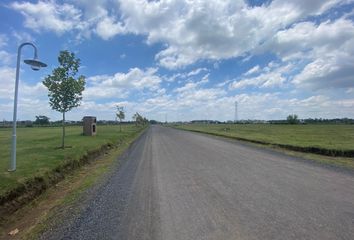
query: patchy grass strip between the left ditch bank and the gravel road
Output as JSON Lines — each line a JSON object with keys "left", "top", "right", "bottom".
{"left": 0, "top": 127, "right": 141, "bottom": 239}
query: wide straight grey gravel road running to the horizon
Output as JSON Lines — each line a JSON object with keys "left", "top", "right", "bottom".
{"left": 42, "top": 126, "right": 354, "bottom": 240}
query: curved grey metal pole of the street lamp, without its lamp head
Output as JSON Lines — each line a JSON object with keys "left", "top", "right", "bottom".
{"left": 8, "top": 43, "right": 37, "bottom": 172}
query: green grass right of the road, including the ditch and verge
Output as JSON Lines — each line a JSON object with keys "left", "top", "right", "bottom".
{"left": 173, "top": 124, "right": 354, "bottom": 169}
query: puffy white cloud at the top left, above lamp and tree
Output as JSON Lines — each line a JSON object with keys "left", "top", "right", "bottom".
{"left": 10, "top": 0, "right": 124, "bottom": 41}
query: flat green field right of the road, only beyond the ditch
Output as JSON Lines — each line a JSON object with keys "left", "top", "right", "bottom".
{"left": 176, "top": 124, "right": 354, "bottom": 150}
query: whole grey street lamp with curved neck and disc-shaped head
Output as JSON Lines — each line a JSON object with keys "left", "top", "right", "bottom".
{"left": 8, "top": 42, "right": 47, "bottom": 172}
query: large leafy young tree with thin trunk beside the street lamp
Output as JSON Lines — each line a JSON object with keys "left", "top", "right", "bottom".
{"left": 43, "top": 51, "right": 85, "bottom": 148}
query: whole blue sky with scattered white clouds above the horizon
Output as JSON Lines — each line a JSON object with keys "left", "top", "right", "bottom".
{"left": 0, "top": 0, "right": 354, "bottom": 121}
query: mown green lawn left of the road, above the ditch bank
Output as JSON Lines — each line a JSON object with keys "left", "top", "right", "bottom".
{"left": 0, "top": 125, "right": 142, "bottom": 195}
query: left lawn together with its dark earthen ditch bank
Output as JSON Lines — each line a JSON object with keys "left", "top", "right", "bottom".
{"left": 0, "top": 125, "right": 142, "bottom": 222}
